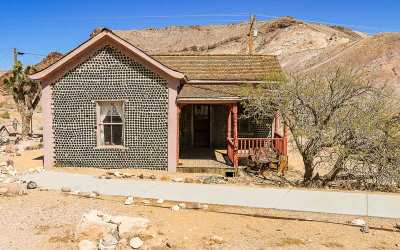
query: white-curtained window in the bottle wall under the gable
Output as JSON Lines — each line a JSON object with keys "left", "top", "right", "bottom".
{"left": 97, "top": 101, "right": 124, "bottom": 147}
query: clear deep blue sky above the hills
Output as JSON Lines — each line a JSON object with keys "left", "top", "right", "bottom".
{"left": 0, "top": 0, "right": 400, "bottom": 70}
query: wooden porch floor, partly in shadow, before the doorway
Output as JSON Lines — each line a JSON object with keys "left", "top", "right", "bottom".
{"left": 179, "top": 148, "right": 233, "bottom": 169}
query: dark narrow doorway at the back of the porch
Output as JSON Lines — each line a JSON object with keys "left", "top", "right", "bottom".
{"left": 193, "top": 104, "right": 210, "bottom": 147}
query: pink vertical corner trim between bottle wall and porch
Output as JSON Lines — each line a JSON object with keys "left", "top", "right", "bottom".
{"left": 168, "top": 80, "right": 179, "bottom": 173}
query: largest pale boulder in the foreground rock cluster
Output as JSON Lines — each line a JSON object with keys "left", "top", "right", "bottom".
{"left": 75, "top": 212, "right": 117, "bottom": 241}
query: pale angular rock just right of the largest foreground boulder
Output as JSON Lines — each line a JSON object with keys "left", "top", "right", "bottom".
{"left": 118, "top": 216, "right": 149, "bottom": 238}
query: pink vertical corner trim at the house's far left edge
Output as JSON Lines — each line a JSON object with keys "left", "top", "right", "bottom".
{"left": 42, "top": 84, "right": 53, "bottom": 168}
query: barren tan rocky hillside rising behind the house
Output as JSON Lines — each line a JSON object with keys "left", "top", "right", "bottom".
{"left": 91, "top": 17, "right": 400, "bottom": 93}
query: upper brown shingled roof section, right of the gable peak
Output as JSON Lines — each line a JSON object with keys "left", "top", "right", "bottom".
{"left": 151, "top": 55, "right": 281, "bottom": 81}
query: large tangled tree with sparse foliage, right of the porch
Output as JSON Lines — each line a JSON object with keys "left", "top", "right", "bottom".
{"left": 242, "top": 68, "right": 400, "bottom": 182}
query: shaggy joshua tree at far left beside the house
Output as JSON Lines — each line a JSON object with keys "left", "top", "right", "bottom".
{"left": 3, "top": 61, "right": 42, "bottom": 137}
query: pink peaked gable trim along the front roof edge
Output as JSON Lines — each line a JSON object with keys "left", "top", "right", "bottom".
{"left": 30, "top": 31, "right": 185, "bottom": 82}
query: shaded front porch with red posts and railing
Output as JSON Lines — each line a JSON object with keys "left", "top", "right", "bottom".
{"left": 177, "top": 98, "right": 287, "bottom": 176}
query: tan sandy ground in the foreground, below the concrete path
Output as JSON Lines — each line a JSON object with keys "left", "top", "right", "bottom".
{"left": 0, "top": 190, "right": 400, "bottom": 249}
